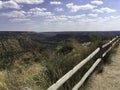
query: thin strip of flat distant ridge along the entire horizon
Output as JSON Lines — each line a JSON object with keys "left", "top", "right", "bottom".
{"left": 0, "top": 31, "right": 120, "bottom": 35}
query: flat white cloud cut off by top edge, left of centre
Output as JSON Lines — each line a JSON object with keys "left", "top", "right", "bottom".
{"left": 12, "top": 0, "right": 44, "bottom": 4}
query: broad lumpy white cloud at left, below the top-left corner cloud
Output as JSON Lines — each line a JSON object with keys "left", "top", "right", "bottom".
{"left": 0, "top": 7, "right": 54, "bottom": 20}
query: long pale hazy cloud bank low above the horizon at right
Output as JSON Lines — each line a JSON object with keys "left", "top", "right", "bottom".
{"left": 38, "top": 16, "right": 120, "bottom": 31}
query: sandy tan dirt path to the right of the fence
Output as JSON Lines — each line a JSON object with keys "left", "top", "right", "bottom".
{"left": 86, "top": 45, "right": 120, "bottom": 90}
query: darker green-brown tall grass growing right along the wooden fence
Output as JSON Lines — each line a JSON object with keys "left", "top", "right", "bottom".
{"left": 40, "top": 42, "right": 97, "bottom": 90}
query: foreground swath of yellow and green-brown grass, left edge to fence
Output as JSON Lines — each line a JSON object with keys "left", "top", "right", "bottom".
{"left": 0, "top": 36, "right": 112, "bottom": 90}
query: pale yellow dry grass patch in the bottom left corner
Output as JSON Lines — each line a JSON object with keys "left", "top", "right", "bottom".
{"left": 0, "top": 62, "right": 44, "bottom": 90}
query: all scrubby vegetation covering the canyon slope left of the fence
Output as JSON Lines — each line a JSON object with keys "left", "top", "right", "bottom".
{"left": 0, "top": 33, "right": 113, "bottom": 90}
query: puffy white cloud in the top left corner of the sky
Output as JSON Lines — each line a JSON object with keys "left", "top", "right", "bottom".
{"left": 0, "top": 1, "right": 20, "bottom": 9}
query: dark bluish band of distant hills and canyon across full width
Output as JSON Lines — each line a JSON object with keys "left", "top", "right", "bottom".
{"left": 0, "top": 31, "right": 120, "bottom": 43}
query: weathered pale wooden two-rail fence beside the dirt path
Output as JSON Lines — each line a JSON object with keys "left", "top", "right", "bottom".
{"left": 47, "top": 36, "right": 120, "bottom": 90}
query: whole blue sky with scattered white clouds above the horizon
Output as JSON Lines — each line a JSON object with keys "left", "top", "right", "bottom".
{"left": 0, "top": 0, "right": 120, "bottom": 32}
